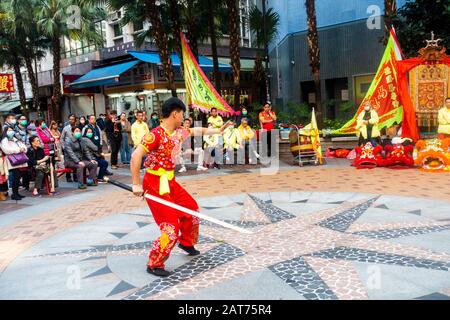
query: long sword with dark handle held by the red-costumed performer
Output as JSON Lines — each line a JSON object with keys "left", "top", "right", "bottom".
{"left": 104, "top": 177, "right": 253, "bottom": 234}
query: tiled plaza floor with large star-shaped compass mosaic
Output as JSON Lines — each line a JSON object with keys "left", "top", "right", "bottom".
{"left": 0, "top": 163, "right": 450, "bottom": 299}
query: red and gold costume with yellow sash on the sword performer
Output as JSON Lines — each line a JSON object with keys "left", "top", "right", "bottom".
{"left": 140, "top": 126, "right": 199, "bottom": 268}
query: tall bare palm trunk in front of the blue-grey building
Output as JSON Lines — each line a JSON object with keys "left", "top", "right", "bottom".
{"left": 305, "top": 0, "right": 323, "bottom": 127}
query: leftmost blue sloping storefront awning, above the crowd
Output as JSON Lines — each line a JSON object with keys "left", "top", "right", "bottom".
{"left": 69, "top": 60, "right": 140, "bottom": 89}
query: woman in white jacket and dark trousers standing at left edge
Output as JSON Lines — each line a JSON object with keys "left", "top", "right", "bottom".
{"left": 1, "top": 128, "right": 28, "bottom": 201}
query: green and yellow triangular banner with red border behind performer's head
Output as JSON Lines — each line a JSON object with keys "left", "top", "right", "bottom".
{"left": 180, "top": 33, "right": 235, "bottom": 117}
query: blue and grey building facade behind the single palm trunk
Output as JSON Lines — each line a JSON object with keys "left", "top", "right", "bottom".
{"left": 269, "top": 0, "right": 406, "bottom": 119}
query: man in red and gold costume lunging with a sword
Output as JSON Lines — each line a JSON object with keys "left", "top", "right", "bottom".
{"left": 131, "top": 98, "right": 228, "bottom": 277}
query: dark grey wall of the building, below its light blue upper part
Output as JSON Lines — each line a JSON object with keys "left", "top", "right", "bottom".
{"left": 270, "top": 19, "right": 384, "bottom": 114}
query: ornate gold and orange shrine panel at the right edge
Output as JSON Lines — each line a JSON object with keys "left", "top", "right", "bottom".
{"left": 409, "top": 32, "right": 450, "bottom": 136}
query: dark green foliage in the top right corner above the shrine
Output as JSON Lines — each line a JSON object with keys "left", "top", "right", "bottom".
{"left": 392, "top": 0, "right": 450, "bottom": 57}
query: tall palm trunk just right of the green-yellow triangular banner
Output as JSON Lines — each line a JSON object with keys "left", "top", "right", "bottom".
{"left": 226, "top": 0, "right": 241, "bottom": 109}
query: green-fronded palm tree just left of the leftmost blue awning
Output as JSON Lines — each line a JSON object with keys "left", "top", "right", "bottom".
{"left": 37, "top": 0, "right": 106, "bottom": 119}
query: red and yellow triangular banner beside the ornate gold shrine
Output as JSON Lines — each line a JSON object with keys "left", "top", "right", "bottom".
{"left": 332, "top": 30, "right": 403, "bottom": 135}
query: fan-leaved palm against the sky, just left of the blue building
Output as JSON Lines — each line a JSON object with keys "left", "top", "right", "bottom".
{"left": 250, "top": 0, "right": 280, "bottom": 100}
